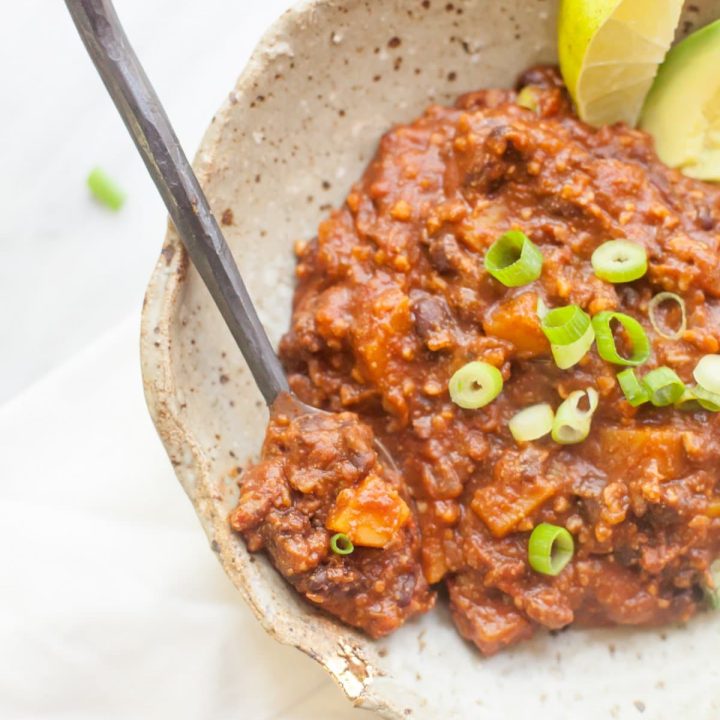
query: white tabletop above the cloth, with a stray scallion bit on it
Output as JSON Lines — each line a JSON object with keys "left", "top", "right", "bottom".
{"left": 0, "top": 0, "right": 291, "bottom": 402}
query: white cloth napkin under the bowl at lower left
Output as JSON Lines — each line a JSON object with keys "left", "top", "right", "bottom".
{"left": 0, "top": 318, "right": 370, "bottom": 720}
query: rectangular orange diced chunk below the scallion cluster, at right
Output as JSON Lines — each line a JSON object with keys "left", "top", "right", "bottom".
{"left": 597, "top": 427, "right": 687, "bottom": 480}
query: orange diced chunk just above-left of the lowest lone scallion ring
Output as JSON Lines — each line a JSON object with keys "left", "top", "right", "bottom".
{"left": 470, "top": 477, "right": 556, "bottom": 538}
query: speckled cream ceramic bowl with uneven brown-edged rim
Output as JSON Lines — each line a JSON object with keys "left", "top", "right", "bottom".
{"left": 142, "top": 0, "right": 720, "bottom": 720}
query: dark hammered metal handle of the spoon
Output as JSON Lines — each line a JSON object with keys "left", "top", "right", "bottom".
{"left": 65, "top": 0, "right": 288, "bottom": 405}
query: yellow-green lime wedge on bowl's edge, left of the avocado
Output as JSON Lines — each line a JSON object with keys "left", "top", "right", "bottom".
{"left": 558, "top": 0, "right": 683, "bottom": 126}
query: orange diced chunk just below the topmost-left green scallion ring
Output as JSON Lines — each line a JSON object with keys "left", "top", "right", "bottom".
{"left": 483, "top": 292, "right": 550, "bottom": 358}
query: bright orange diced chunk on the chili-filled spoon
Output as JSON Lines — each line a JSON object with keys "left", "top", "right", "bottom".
{"left": 326, "top": 474, "right": 410, "bottom": 548}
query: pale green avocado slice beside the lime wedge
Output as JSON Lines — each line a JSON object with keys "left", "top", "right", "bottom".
{"left": 640, "top": 20, "right": 720, "bottom": 182}
